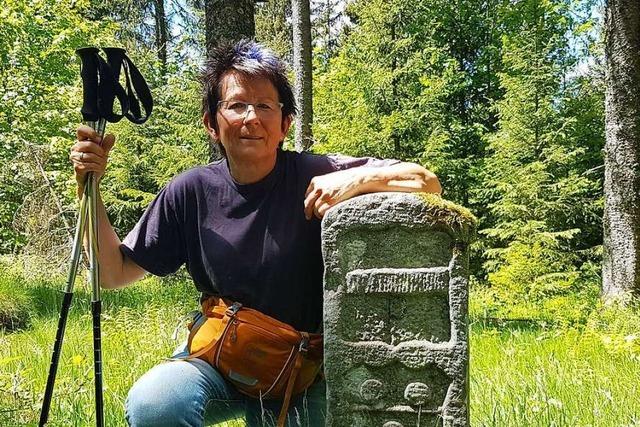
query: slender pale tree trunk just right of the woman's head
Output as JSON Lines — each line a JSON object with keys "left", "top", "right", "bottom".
{"left": 291, "top": 0, "right": 313, "bottom": 151}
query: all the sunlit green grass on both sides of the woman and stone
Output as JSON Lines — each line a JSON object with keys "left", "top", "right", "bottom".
{"left": 0, "top": 271, "right": 640, "bottom": 427}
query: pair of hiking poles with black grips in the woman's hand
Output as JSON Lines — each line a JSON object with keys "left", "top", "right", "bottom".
{"left": 39, "top": 47, "right": 153, "bottom": 427}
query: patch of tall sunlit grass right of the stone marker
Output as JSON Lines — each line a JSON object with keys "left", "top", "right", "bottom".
{"left": 470, "top": 326, "right": 640, "bottom": 427}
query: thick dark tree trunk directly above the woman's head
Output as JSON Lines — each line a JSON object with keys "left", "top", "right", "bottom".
{"left": 204, "top": 0, "right": 256, "bottom": 56}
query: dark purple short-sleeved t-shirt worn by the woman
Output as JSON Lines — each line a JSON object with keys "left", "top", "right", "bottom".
{"left": 120, "top": 150, "right": 397, "bottom": 331}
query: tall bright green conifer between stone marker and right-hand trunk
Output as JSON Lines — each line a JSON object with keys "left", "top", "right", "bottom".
{"left": 476, "top": 0, "right": 604, "bottom": 314}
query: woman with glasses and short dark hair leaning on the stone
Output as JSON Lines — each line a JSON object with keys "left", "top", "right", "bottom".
{"left": 70, "top": 41, "right": 440, "bottom": 427}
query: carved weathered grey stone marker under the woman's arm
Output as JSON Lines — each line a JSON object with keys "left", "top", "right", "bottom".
{"left": 322, "top": 193, "right": 475, "bottom": 427}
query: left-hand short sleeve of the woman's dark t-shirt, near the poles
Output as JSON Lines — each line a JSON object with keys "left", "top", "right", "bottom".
{"left": 120, "top": 184, "right": 186, "bottom": 276}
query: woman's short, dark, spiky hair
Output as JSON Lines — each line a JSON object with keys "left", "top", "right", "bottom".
{"left": 200, "top": 40, "right": 296, "bottom": 140}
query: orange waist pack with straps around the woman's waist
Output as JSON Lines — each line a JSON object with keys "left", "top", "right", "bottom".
{"left": 176, "top": 297, "right": 323, "bottom": 425}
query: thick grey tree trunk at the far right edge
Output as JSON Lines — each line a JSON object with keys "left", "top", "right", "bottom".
{"left": 602, "top": 0, "right": 640, "bottom": 298}
